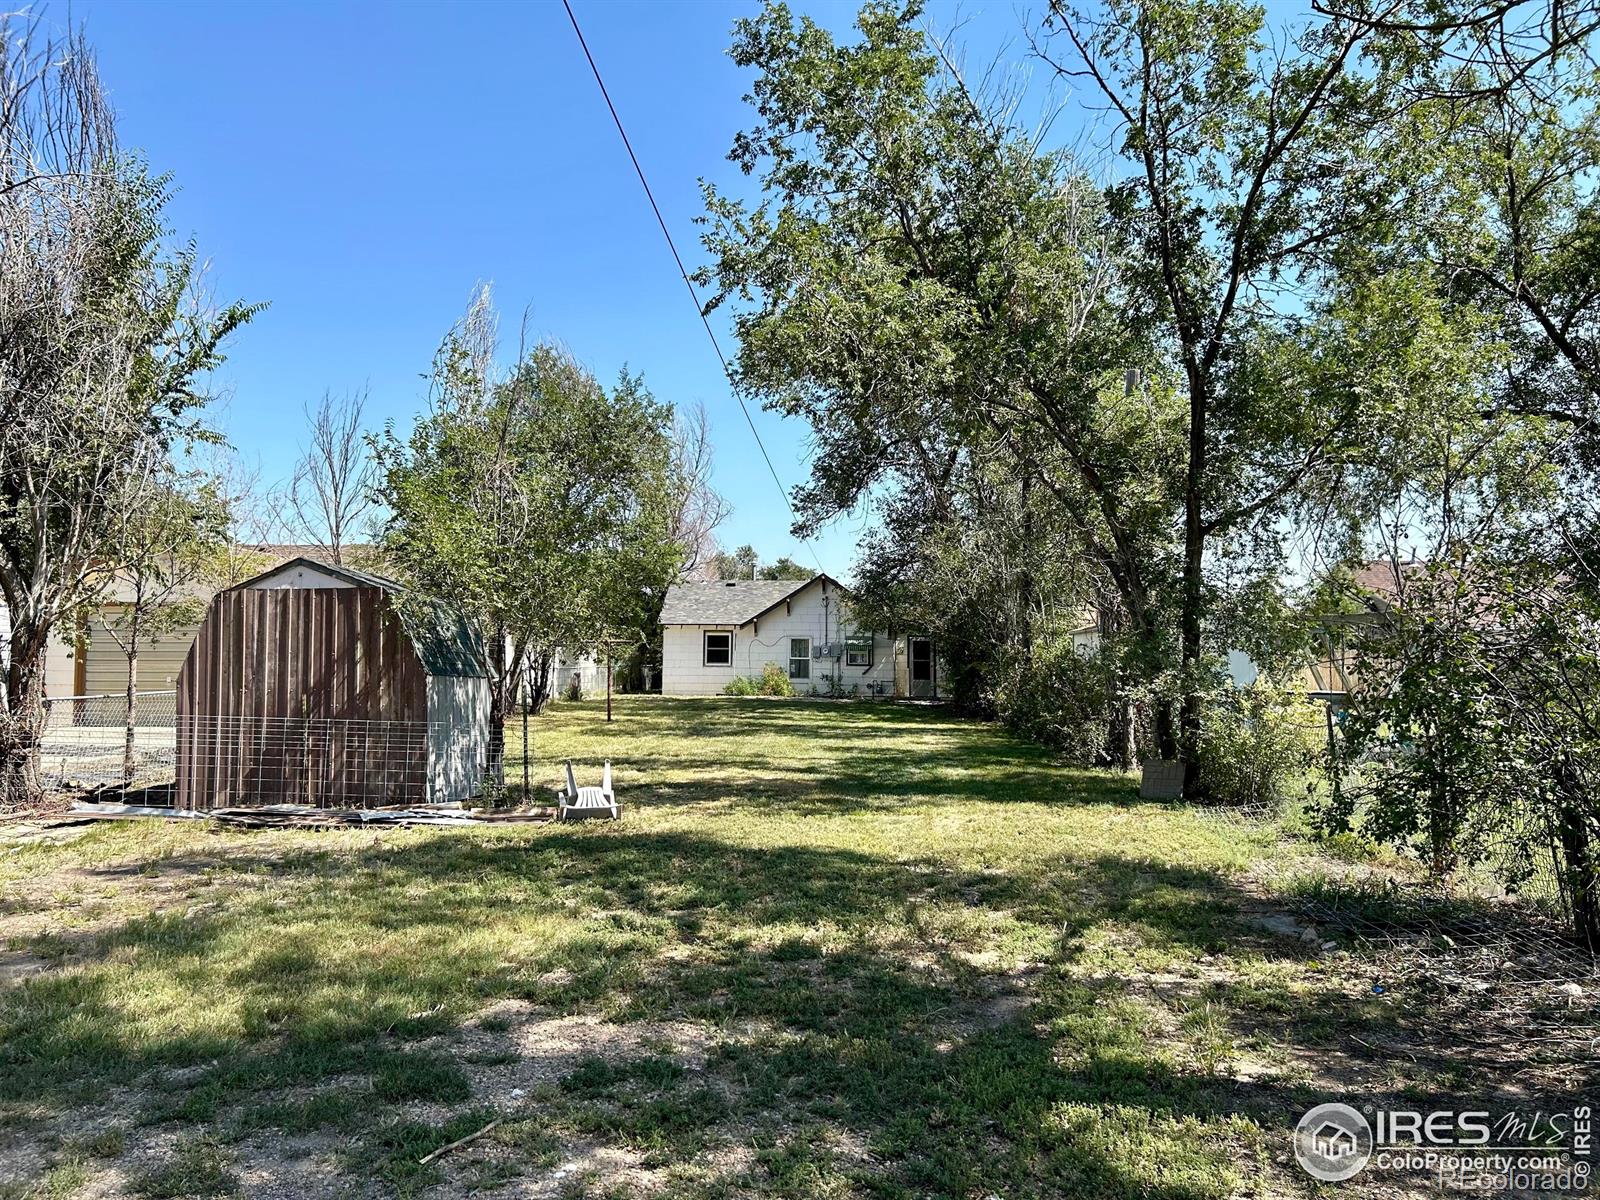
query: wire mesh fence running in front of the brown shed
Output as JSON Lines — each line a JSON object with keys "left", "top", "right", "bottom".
{"left": 40, "top": 693, "right": 482, "bottom": 810}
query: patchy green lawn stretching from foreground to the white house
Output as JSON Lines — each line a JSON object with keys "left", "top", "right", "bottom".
{"left": 0, "top": 698, "right": 1580, "bottom": 1198}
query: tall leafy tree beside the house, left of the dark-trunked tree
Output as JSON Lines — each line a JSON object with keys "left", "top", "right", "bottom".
{"left": 707, "top": 5, "right": 1179, "bottom": 752}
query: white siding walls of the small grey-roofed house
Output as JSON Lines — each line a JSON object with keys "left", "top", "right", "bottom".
{"left": 661, "top": 581, "right": 894, "bottom": 696}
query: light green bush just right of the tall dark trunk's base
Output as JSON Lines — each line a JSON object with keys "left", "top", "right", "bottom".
{"left": 1200, "top": 685, "right": 1325, "bottom": 808}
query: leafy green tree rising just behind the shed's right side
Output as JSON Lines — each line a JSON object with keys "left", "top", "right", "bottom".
{"left": 376, "top": 291, "right": 685, "bottom": 770}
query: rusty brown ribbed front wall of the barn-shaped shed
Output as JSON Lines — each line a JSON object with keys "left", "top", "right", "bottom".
{"left": 178, "top": 587, "right": 427, "bottom": 808}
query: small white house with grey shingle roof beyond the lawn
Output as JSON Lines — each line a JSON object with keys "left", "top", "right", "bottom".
{"left": 661, "top": 574, "right": 941, "bottom": 699}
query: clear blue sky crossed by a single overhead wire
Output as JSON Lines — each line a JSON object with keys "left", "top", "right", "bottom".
{"left": 59, "top": 0, "right": 1022, "bottom": 574}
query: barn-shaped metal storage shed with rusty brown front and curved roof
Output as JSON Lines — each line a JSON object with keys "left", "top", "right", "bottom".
{"left": 176, "top": 558, "right": 490, "bottom": 808}
